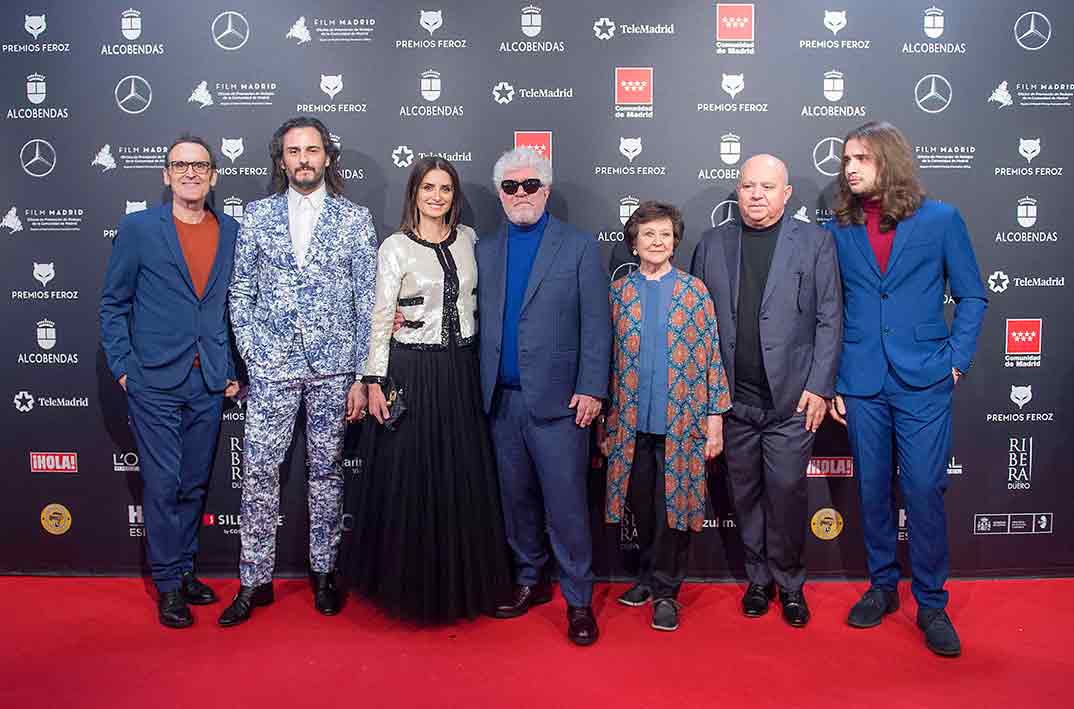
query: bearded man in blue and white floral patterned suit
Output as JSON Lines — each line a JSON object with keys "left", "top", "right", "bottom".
{"left": 219, "top": 117, "right": 377, "bottom": 625}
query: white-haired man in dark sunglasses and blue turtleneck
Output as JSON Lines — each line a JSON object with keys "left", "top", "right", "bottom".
{"left": 477, "top": 148, "right": 611, "bottom": 646}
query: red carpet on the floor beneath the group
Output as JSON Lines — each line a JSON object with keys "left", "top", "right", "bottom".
{"left": 0, "top": 577, "right": 1074, "bottom": 709}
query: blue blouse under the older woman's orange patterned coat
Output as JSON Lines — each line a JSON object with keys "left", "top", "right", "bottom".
{"left": 633, "top": 269, "right": 676, "bottom": 435}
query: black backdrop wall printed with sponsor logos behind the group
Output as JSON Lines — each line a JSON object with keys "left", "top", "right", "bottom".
{"left": 0, "top": 0, "right": 1074, "bottom": 578}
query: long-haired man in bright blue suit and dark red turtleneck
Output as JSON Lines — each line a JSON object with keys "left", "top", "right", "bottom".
{"left": 829, "top": 122, "right": 988, "bottom": 656}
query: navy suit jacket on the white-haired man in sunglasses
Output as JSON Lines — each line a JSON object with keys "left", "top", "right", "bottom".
{"left": 476, "top": 216, "right": 611, "bottom": 419}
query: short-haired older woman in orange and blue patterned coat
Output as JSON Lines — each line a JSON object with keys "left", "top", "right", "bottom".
{"left": 597, "top": 202, "right": 730, "bottom": 631}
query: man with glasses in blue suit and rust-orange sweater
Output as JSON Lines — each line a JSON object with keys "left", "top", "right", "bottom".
{"left": 100, "top": 135, "right": 238, "bottom": 627}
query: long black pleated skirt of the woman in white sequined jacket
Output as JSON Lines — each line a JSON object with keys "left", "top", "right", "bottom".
{"left": 340, "top": 346, "right": 511, "bottom": 624}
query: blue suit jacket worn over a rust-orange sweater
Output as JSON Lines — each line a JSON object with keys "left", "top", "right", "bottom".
{"left": 100, "top": 202, "right": 238, "bottom": 391}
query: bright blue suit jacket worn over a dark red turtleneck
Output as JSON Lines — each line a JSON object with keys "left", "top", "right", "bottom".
{"left": 827, "top": 200, "right": 988, "bottom": 396}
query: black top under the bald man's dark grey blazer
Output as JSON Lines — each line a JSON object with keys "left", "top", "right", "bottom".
{"left": 735, "top": 217, "right": 783, "bottom": 409}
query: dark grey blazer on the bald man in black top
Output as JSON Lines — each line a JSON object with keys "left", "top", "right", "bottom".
{"left": 691, "top": 215, "right": 843, "bottom": 417}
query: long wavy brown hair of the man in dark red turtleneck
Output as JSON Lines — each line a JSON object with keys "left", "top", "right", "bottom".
{"left": 834, "top": 120, "right": 925, "bottom": 231}
